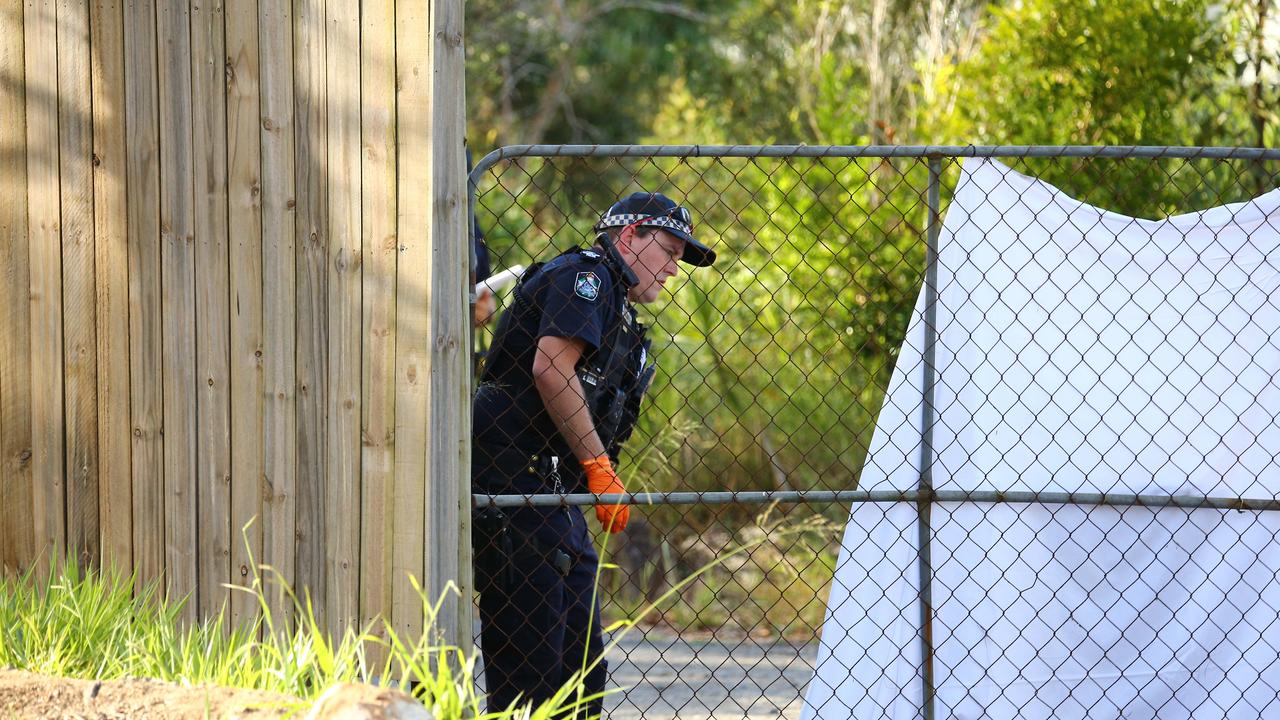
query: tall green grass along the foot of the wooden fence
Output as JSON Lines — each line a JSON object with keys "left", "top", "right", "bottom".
{"left": 0, "top": 550, "right": 581, "bottom": 720}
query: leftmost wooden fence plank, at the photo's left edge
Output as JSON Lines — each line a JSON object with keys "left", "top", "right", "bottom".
{"left": 0, "top": 3, "right": 36, "bottom": 577}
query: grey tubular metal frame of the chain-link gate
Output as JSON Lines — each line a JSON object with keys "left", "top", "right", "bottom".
{"left": 462, "top": 145, "right": 1280, "bottom": 720}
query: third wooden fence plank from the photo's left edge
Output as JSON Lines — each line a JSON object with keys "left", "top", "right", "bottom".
{"left": 58, "top": 0, "right": 101, "bottom": 568}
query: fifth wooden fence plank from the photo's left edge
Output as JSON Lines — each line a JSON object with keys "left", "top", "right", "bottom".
{"left": 124, "top": 0, "right": 166, "bottom": 589}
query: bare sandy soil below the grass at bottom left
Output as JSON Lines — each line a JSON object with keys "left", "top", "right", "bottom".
{"left": 0, "top": 669, "right": 306, "bottom": 720}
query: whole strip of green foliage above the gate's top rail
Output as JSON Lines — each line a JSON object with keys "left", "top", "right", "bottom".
{"left": 467, "top": 0, "right": 1280, "bottom": 150}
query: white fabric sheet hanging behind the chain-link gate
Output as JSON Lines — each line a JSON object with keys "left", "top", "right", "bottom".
{"left": 803, "top": 159, "right": 1280, "bottom": 720}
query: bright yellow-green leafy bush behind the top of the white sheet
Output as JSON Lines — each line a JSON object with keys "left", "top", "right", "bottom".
{"left": 920, "top": 0, "right": 1274, "bottom": 212}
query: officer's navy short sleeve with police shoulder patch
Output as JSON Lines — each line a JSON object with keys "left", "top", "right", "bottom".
{"left": 538, "top": 263, "right": 613, "bottom": 348}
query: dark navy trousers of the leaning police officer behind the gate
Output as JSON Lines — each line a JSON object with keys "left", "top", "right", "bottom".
{"left": 472, "top": 447, "right": 608, "bottom": 719}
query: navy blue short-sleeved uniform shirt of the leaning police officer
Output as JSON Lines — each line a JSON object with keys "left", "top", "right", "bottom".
{"left": 472, "top": 250, "right": 634, "bottom": 457}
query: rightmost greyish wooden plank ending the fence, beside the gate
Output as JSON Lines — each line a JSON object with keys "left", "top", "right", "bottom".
{"left": 425, "top": 0, "right": 471, "bottom": 647}
